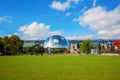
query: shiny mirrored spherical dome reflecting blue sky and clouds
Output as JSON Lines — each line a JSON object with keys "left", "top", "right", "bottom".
{"left": 44, "top": 35, "right": 69, "bottom": 48}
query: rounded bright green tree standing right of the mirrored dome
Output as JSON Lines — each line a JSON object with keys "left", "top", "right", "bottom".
{"left": 80, "top": 39, "right": 92, "bottom": 53}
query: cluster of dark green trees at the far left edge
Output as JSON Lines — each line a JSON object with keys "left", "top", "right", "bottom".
{"left": 0, "top": 35, "right": 23, "bottom": 55}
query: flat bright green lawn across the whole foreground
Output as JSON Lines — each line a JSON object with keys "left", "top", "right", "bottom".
{"left": 0, "top": 55, "right": 120, "bottom": 80}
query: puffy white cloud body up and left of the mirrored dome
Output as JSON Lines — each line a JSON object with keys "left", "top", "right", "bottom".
{"left": 18, "top": 22, "right": 50, "bottom": 38}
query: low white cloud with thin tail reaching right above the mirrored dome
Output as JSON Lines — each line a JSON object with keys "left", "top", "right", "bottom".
{"left": 17, "top": 22, "right": 62, "bottom": 40}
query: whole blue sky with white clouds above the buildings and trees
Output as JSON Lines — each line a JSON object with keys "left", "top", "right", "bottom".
{"left": 0, "top": 0, "right": 120, "bottom": 40}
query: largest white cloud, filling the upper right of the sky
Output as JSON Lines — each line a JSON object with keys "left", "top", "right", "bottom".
{"left": 78, "top": 6, "right": 120, "bottom": 38}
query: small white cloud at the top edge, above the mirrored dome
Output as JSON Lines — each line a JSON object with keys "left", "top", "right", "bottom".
{"left": 50, "top": 0, "right": 79, "bottom": 11}
